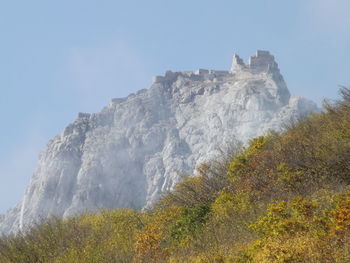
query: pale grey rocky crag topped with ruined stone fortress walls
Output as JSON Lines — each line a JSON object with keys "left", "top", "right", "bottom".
{"left": 0, "top": 51, "right": 317, "bottom": 234}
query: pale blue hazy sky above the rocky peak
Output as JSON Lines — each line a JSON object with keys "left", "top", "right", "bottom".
{"left": 0, "top": 0, "right": 350, "bottom": 213}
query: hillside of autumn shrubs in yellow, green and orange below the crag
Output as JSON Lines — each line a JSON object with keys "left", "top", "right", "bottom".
{"left": 0, "top": 88, "right": 350, "bottom": 263}
